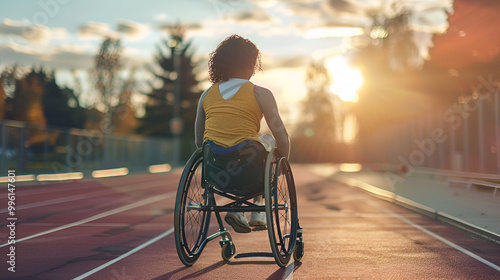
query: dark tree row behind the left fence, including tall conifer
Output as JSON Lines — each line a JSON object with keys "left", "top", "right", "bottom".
{"left": 0, "top": 24, "right": 201, "bottom": 161}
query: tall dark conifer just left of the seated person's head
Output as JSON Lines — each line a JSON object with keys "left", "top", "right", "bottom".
{"left": 137, "top": 24, "right": 201, "bottom": 157}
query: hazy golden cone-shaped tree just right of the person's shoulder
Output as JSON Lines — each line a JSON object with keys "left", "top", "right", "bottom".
{"left": 291, "top": 62, "right": 336, "bottom": 162}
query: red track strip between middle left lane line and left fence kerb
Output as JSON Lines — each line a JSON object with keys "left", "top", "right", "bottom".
{"left": 0, "top": 175, "right": 177, "bottom": 240}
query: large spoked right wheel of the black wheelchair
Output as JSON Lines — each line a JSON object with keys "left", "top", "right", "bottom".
{"left": 265, "top": 153, "right": 298, "bottom": 267}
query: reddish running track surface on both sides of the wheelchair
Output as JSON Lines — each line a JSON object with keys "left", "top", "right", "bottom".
{"left": 2, "top": 165, "right": 500, "bottom": 279}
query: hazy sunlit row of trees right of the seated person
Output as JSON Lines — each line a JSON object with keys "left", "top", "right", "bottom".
{"left": 292, "top": 0, "right": 500, "bottom": 162}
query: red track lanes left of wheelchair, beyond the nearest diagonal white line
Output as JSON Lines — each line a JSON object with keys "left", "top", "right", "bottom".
{"left": 1, "top": 173, "right": 178, "bottom": 279}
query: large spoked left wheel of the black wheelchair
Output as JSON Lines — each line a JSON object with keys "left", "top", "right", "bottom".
{"left": 174, "top": 149, "right": 210, "bottom": 266}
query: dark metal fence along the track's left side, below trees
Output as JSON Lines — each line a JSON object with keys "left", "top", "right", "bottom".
{"left": 0, "top": 120, "right": 174, "bottom": 177}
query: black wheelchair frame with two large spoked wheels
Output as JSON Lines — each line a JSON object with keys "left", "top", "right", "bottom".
{"left": 174, "top": 148, "right": 304, "bottom": 267}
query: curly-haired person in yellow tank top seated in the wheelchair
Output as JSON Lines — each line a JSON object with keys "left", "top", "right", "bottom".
{"left": 195, "top": 35, "right": 290, "bottom": 233}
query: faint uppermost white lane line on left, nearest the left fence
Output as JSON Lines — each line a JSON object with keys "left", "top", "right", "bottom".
{"left": 0, "top": 180, "right": 170, "bottom": 213}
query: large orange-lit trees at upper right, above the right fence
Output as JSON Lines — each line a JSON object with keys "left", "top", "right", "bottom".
{"left": 352, "top": 0, "right": 500, "bottom": 164}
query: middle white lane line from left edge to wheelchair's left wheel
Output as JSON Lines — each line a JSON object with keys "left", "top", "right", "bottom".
{"left": 0, "top": 191, "right": 177, "bottom": 248}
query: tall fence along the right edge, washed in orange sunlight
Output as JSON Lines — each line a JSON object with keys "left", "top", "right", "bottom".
{"left": 364, "top": 89, "right": 500, "bottom": 178}
